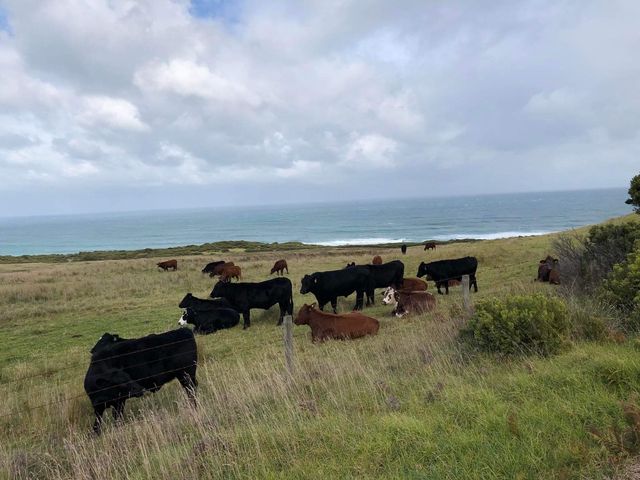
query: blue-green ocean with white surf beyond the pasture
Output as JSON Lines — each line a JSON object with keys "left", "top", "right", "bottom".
{"left": 0, "top": 188, "right": 632, "bottom": 255}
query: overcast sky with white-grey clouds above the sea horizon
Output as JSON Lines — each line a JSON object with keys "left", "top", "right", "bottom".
{"left": 0, "top": 0, "right": 640, "bottom": 216}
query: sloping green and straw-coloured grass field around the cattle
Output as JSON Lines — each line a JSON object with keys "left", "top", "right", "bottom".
{"left": 0, "top": 218, "right": 640, "bottom": 479}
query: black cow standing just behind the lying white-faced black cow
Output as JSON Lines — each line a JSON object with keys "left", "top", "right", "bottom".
{"left": 210, "top": 277, "right": 293, "bottom": 328}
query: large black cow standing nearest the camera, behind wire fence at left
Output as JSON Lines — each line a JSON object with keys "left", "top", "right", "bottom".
{"left": 84, "top": 328, "right": 198, "bottom": 434}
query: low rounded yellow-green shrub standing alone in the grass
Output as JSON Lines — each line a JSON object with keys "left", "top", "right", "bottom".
{"left": 461, "top": 294, "right": 570, "bottom": 355}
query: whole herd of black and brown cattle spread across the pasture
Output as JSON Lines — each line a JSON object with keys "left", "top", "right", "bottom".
{"left": 84, "top": 244, "right": 559, "bottom": 434}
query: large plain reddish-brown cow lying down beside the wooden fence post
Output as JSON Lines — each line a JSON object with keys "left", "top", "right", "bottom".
{"left": 293, "top": 304, "right": 380, "bottom": 342}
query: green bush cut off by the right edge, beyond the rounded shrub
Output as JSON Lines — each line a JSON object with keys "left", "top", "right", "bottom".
{"left": 600, "top": 245, "right": 640, "bottom": 331}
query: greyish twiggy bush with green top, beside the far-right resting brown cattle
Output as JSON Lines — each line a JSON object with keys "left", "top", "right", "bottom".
{"left": 553, "top": 222, "right": 640, "bottom": 293}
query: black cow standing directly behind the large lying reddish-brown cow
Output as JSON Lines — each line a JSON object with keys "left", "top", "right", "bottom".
{"left": 300, "top": 266, "right": 375, "bottom": 313}
